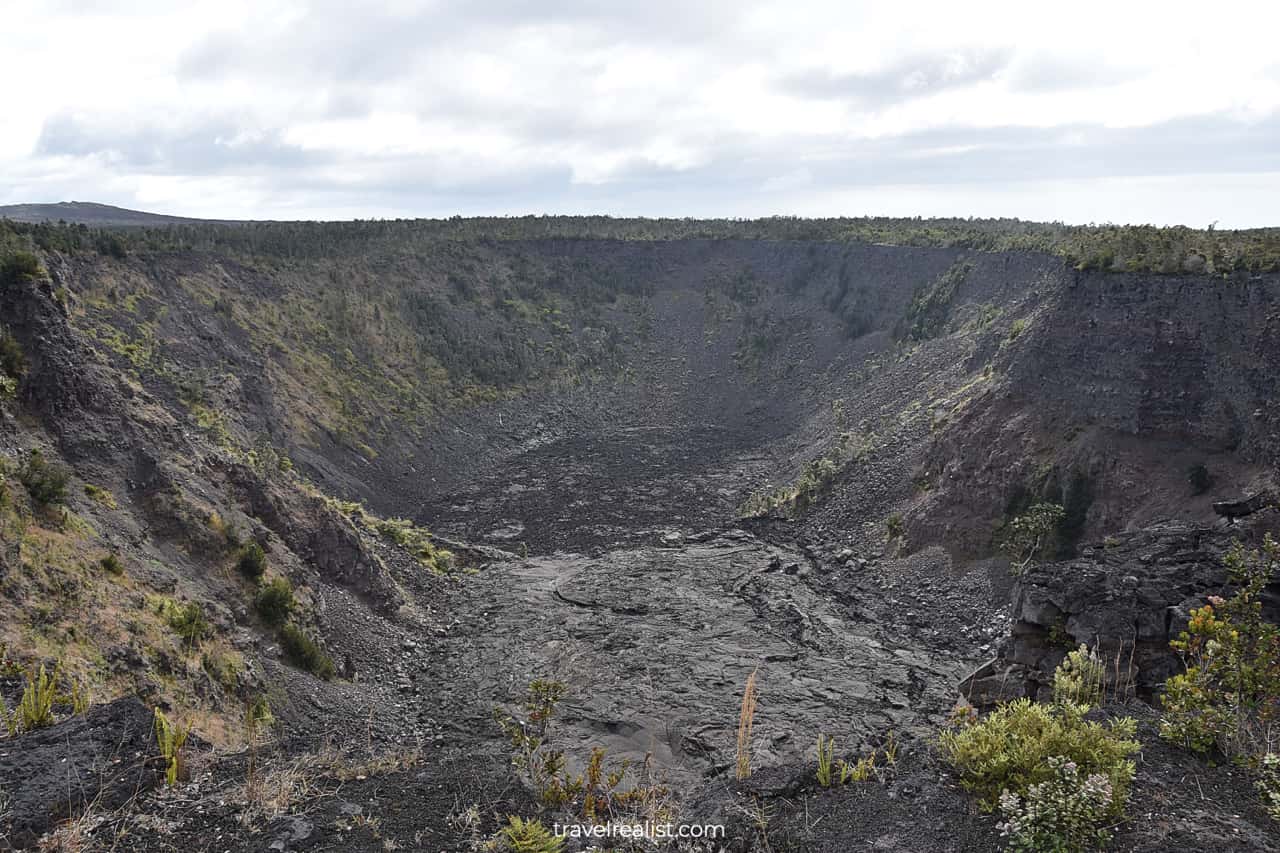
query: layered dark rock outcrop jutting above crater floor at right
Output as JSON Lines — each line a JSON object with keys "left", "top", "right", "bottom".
{"left": 960, "top": 514, "right": 1280, "bottom": 707}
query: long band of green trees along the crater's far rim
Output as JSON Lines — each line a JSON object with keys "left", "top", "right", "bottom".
{"left": 10, "top": 216, "right": 1280, "bottom": 272}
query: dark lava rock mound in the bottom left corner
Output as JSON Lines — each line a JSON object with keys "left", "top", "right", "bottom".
{"left": 0, "top": 697, "right": 161, "bottom": 848}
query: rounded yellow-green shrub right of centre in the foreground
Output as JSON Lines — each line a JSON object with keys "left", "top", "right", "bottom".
{"left": 940, "top": 699, "right": 1140, "bottom": 816}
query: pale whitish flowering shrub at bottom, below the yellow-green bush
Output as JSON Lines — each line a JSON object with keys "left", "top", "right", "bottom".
{"left": 1000, "top": 756, "right": 1112, "bottom": 853}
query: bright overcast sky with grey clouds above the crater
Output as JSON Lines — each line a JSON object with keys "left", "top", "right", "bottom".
{"left": 0, "top": 0, "right": 1280, "bottom": 228}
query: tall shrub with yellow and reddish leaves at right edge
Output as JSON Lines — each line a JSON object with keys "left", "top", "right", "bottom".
{"left": 1160, "top": 535, "right": 1280, "bottom": 758}
